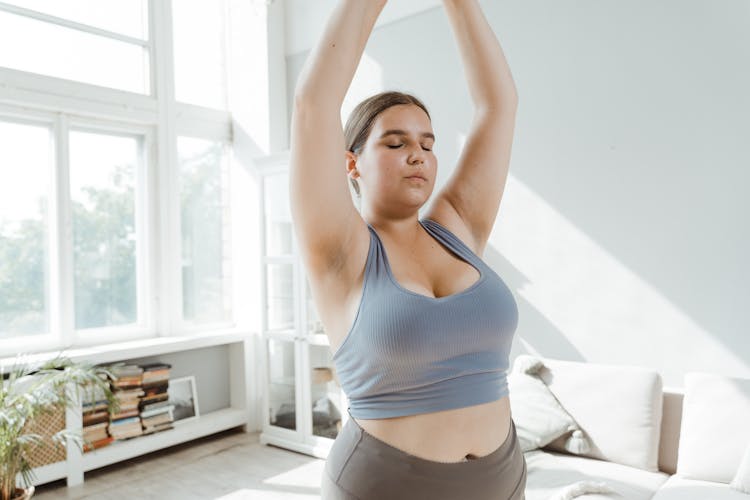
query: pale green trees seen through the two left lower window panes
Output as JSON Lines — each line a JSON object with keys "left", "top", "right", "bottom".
{"left": 0, "top": 165, "right": 137, "bottom": 338}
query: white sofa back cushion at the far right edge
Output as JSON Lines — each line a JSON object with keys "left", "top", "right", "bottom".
{"left": 676, "top": 372, "right": 750, "bottom": 484}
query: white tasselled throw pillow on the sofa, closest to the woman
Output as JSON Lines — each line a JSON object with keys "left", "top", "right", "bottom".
{"left": 508, "top": 354, "right": 589, "bottom": 453}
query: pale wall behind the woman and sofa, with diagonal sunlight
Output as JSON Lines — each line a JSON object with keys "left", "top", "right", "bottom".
{"left": 285, "top": 0, "right": 750, "bottom": 387}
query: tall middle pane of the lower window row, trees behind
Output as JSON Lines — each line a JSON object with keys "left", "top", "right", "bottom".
{"left": 70, "top": 131, "right": 141, "bottom": 329}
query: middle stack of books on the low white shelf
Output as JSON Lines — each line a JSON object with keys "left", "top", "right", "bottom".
{"left": 109, "top": 363, "right": 144, "bottom": 439}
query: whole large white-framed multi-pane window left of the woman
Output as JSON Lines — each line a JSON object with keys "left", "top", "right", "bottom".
{"left": 0, "top": 0, "right": 238, "bottom": 356}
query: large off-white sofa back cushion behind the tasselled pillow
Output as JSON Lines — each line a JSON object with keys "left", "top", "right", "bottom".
{"left": 538, "top": 358, "right": 662, "bottom": 472}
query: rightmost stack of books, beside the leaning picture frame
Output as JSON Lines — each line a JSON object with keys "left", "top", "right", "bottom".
{"left": 140, "top": 363, "right": 174, "bottom": 434}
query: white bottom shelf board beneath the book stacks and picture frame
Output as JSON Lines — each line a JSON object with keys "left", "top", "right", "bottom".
{"left": 83, "top": 408, "right": 248, "bottom": 472}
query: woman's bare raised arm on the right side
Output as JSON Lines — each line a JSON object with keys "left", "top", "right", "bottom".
{"left": 431, "top": 0, "right": 518, "bottom": 255}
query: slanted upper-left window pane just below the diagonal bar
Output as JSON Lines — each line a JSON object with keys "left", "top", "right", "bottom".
{"left": 0, "top": 11, "right": 149, "bottom": 94}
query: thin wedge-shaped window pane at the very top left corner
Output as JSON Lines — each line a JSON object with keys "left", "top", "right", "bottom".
{"left": 5, "top": 0, "right": 148, "bottom": 40}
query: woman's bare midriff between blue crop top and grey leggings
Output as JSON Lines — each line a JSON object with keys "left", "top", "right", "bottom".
{"left": 355, "top": 396, "right": 511, "bottom": 462}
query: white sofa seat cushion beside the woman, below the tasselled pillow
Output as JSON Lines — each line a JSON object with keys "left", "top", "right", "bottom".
{"left": 524, "top": 450, "right": 668, "bottom": 500}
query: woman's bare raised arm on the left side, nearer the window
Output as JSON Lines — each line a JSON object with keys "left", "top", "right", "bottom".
{"left": 289, "top": 0, "right": 386, "bottom": 272}
